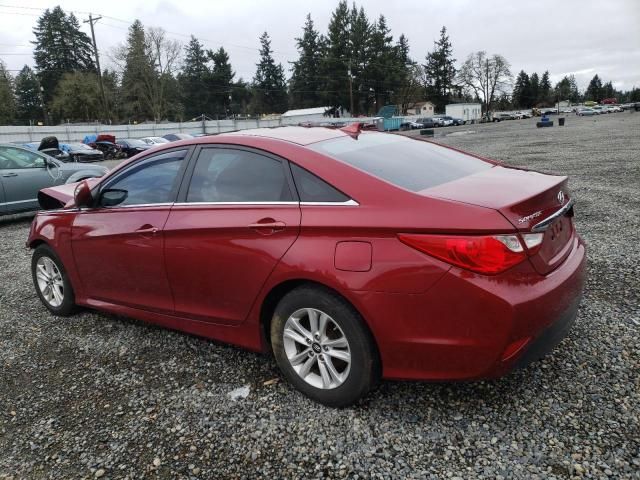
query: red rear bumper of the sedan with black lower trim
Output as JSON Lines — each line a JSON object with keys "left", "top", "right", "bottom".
{"left": 353, "top": 235, "right": 586, "bottom": 380}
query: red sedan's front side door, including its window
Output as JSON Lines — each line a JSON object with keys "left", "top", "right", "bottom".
{"left": 71, "top": 148, "right": 188, "bottom": 312}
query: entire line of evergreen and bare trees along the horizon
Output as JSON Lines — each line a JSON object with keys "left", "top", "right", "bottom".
{"left": 0, "top": 0, "right": 640, "bottom": 124}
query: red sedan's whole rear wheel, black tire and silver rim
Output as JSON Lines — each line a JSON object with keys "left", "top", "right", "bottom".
{"left": 271, "top": 286, "right": 380, "bottom": 407}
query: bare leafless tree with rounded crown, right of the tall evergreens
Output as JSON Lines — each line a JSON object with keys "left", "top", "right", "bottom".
{"left": 458, "top": 51, "right": 512, "bottom": 112}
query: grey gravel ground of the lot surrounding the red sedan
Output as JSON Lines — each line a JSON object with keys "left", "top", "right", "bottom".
{"left": 0, "top": 113, "right": 640, "bottom": 479}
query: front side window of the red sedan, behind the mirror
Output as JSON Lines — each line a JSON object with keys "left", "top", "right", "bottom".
{"left": 104, "top": 150, "right": 187, "bottom": 206}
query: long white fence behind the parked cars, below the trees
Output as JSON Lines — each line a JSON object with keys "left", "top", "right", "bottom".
{"left": 0, "top": 118, "right": 380, "bottom": 143}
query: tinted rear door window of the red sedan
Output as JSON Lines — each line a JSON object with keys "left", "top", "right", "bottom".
{"left": 187, "top": 148, "right": 293, "bottom": 202}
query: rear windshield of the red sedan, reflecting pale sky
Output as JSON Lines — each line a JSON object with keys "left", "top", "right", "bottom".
{"left": 309, "top": 133, "right": 493, "bottom": 192}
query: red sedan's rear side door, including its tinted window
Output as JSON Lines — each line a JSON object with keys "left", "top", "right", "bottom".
{"left": 164, "top": 146, "right": 301, "bottom": 324}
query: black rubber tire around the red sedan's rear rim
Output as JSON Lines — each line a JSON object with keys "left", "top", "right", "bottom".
{"left": 270, "top": 286, "right": 380, "bottom": 408}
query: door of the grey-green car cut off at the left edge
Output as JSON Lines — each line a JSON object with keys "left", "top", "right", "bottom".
{"left": 0, "top": 146, "right": 58, "bottom": 213}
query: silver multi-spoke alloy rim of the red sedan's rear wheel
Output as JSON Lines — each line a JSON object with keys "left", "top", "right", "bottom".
{"left": 283, "top": 308, "right": 351, "bottom": 390}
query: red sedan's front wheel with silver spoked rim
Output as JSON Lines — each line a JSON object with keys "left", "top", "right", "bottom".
{"left": 31, "top": 244, "right": 76, "bottom": 316}
